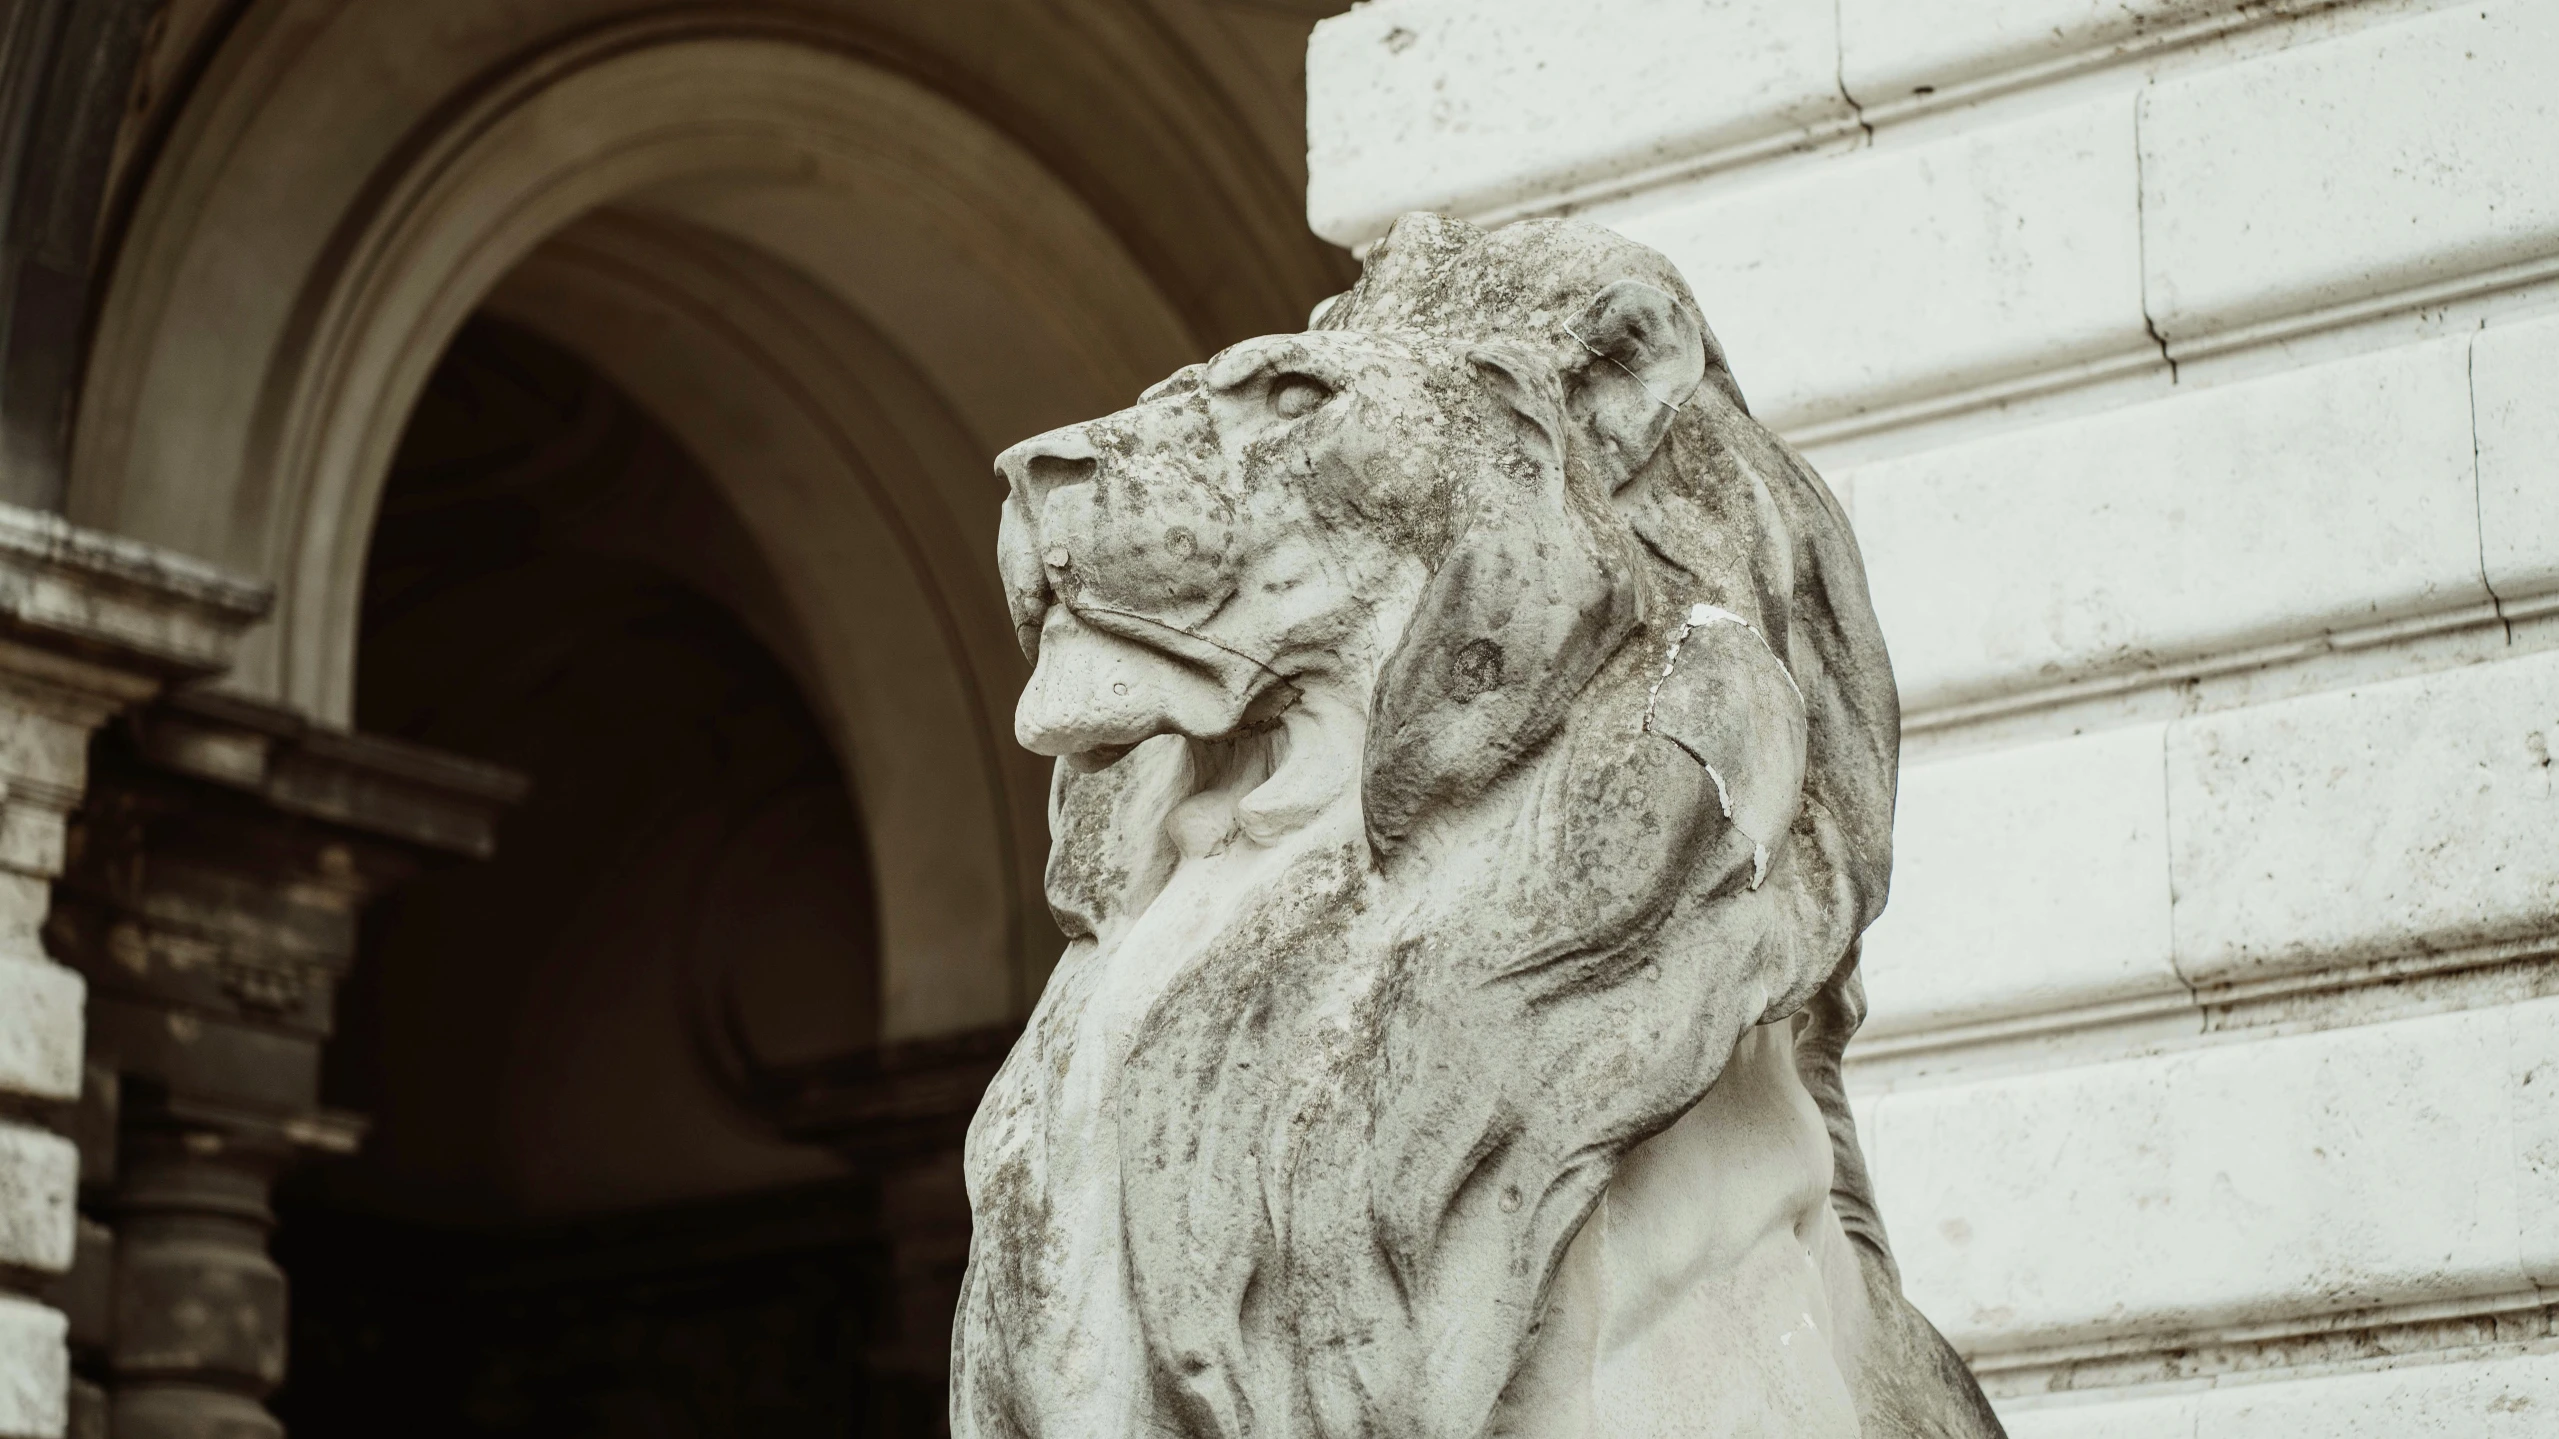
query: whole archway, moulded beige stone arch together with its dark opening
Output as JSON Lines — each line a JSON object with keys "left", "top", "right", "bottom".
{"left": 67, "top": 0, "right": 1346, "bottom": 1436}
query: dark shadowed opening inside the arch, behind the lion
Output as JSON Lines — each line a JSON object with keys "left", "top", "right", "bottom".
{"left": 279, "top": 318, "right": 939, "bottom": 1439}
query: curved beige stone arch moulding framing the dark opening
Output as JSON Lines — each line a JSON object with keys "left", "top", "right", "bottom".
{"left": 69, "top": 11, "right": 1228, "bottom": 1037}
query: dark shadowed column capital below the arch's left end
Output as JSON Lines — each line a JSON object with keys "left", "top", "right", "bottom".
{"left": 49, "top": 694, "right": 525, "bottom": 1121}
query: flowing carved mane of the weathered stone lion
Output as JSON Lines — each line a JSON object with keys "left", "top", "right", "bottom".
{"left": 955, "top": 215, "right": 1899, "bottom": 1439}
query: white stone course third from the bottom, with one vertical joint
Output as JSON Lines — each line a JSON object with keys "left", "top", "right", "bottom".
{"left": 1866, "top": 650, "right": 2559, "bottom": 1034}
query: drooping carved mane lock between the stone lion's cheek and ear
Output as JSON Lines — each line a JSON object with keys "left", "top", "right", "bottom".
{"left": 1361, "top": 348, "right": 1635, "bottom": 855}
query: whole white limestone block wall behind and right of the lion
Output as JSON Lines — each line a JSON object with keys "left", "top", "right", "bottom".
{"left": 1308, "top": 0, "right": 2559, "bottom": 1439}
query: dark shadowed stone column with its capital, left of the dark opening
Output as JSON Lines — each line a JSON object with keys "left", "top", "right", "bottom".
{"left": 46, "top": 694, "right": 525, "bottom": 1439}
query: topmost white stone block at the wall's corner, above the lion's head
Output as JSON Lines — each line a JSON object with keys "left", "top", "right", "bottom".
{"left": 1308, "top": 0, "right": 1850, "bottom": 246}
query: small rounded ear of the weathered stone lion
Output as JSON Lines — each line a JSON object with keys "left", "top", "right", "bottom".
{"left": 1569, "top": 279, "right": 1712, "bottom": 494}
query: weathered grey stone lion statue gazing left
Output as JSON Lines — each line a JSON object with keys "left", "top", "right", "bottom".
{"left": 952, "top": 215, "right": 1999, "bottom": 1439}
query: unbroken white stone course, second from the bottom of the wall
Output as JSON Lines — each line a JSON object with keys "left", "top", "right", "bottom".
{"left": 1871, "top": 1001, "right": 2559, "bottom": 1355}
